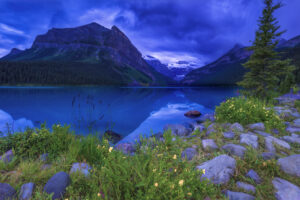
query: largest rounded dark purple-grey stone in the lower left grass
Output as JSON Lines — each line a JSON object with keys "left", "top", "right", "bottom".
{"left": 44, "top": 172, "right": 71, "bottom": 200}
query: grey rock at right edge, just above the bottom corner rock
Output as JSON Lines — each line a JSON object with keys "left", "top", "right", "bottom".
{"left": 277, "top": 154, "right": 300, "bottom": 177}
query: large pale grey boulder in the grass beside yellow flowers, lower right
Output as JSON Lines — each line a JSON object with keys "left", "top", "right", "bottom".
{"left": 197, "top": 155, "right": 236, "bottom": 184}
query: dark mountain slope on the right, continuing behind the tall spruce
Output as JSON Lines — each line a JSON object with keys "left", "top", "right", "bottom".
{"left": 181, "top": 36, "right": 300, "bottom": 86}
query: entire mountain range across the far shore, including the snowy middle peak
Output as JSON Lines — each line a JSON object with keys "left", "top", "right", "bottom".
{"left": 0, "top": 23, "right": 300, "bottom": 86}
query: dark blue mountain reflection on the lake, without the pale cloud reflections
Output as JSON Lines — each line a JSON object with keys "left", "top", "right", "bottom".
{"left": 0, "top": 87, "right": 237, "bottom": 136}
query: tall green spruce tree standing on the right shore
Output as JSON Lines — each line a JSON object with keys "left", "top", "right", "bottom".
{"left": 238, "top": 0, "right": 295, "bottom": 98}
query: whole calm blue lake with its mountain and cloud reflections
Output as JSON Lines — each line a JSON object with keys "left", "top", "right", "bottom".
{"left": 0, "top": 87, "right": 237, "bottom": 141}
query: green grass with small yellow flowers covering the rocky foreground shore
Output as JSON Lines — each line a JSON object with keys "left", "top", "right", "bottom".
{"left": 0, "top": 96, "right": 300, "bottom": 200}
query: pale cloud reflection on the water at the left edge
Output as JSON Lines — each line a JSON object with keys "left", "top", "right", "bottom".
{"left": 0, "top": 110, "right": 34, "bottom": 133}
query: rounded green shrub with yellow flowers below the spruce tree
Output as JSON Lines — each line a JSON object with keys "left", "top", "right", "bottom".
{"left": 216, "top": 97, "right": 284, "bottom": 131}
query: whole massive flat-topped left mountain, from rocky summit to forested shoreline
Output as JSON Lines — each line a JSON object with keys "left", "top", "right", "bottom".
{"left": 0, "top": 23, "right": 167, "bottom": 85}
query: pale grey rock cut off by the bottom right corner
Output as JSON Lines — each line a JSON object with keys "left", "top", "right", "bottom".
{"left": 272, "top": 178, "right": 300, "bottom": 200}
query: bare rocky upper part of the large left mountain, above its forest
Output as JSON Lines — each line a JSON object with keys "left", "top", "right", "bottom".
{"left": 1, "top": 23, "right": 169, "bottom": 83}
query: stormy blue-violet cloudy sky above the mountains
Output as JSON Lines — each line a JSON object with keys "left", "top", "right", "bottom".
{"left": 0, "top": 0, "right": 300, "bottom": 66}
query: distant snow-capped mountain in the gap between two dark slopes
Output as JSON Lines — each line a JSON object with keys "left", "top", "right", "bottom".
{"left": 144, "top": 55, "right": 195, "bottom": 81}
